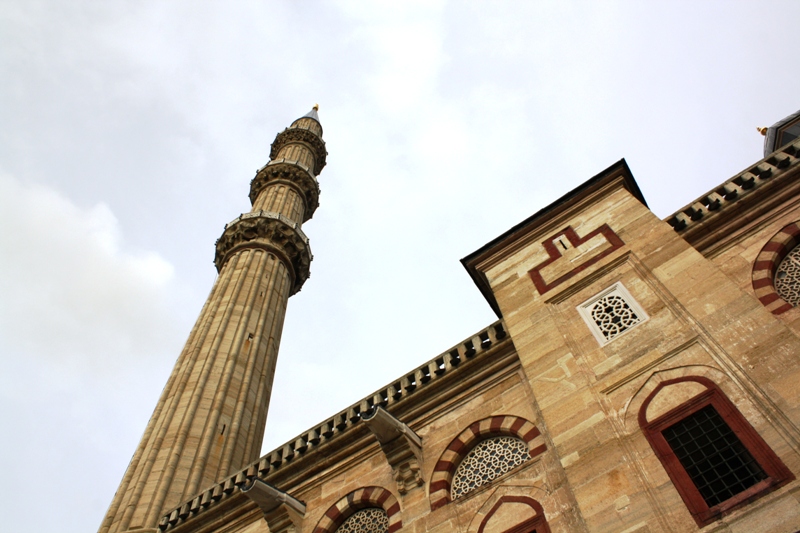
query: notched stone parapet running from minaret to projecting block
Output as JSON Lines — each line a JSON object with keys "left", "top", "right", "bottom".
{"left": 159, "top": 320, "right": 511, "bottom": 531}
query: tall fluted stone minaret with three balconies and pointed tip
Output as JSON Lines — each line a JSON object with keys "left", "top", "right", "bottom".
{"left": 100, "top": 105, "right": 327, "bottom": 533}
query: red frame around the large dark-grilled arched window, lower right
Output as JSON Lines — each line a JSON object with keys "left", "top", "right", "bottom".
{"left": 639, "top": 376, "right": 794, "bottom": 527}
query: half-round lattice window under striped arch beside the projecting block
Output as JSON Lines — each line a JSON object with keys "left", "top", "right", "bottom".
{"left": 452, "top": 437, "right": 531, "bottom": 500}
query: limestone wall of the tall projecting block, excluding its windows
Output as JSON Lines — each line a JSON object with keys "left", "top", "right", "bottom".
{"left": 479, "top": 171, "right": 800, "bottom": 532}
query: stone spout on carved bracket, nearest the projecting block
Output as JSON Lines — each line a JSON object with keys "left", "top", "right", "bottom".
{"left": 361, "top": 407, "right": 424, "bottom": 494}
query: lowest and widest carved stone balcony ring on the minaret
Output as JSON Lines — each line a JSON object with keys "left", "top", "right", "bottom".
{"left": 214, "top": 211, "right": 313, "bottom": 295}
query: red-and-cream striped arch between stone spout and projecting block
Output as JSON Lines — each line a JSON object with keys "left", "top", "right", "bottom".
{"left": 428, "top": 415, "right": 547, "bottom": 510}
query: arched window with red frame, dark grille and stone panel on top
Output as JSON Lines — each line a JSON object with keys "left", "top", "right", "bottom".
{"left": 639, "top": 376, "right": 794, "bottom": 527}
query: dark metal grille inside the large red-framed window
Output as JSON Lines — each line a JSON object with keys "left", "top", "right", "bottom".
{"left": 662, "top": 405, "right": 767, "bottom": 507}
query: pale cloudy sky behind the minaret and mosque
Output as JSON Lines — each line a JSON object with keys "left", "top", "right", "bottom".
{"left": 0, "top": 0, "right": 800, "bottom": 533}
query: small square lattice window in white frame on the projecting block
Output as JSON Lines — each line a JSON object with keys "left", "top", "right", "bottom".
{"left": 578, "top": 282, "right": 648, "bottom": 345}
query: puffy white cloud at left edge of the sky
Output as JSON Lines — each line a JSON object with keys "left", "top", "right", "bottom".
{"left": 0, "top": 175, "right": 173, "bottom": 368}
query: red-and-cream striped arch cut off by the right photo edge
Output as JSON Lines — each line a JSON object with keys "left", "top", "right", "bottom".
{"left": 752, "top": 221, "right": 800, "bottom": 315}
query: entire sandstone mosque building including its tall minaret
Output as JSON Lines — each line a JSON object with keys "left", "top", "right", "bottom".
{"left": 100, "top": 108, "right": 800, "bottom": 533}
